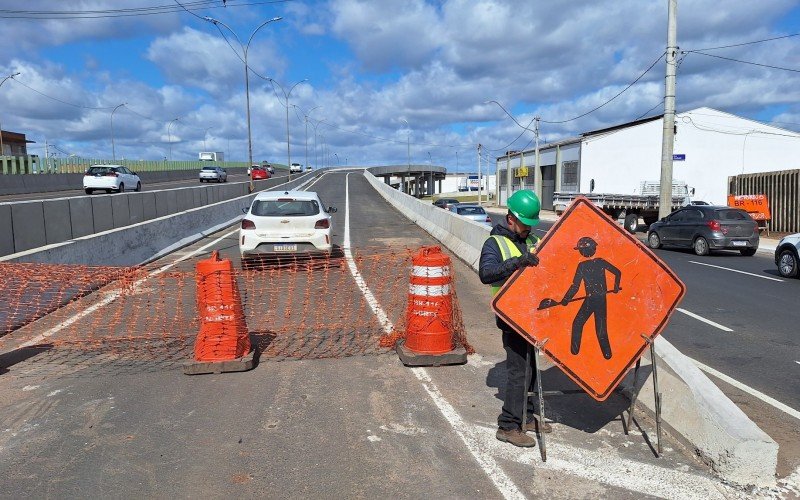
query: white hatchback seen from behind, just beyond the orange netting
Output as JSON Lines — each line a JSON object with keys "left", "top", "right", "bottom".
{"left": 239, "top": 191, "right": 336, "bottom": 266}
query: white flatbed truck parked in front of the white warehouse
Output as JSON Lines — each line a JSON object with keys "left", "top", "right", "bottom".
{"left": 553, "top": 181, "right": 702, "bottom": 233}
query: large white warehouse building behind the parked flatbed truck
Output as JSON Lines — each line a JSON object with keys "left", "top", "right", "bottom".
{"left": 497, "top": 107, "right": 800, "bottom": 209}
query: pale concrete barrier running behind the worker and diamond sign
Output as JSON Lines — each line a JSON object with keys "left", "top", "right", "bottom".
{"left": 365, "top": 171, "right": 778, "bottom": 487}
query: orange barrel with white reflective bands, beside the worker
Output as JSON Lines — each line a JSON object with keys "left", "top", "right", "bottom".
{"left": 395, "top": 246, "right": 467, "bottom": 366}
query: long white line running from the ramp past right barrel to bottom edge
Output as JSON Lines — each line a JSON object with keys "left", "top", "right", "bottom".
{"left": 342, "top": 173, "right": 525, "bottom": 499}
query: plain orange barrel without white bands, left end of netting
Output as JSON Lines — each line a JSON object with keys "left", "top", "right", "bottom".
{"left": 183, "top": 251, "right": 255, "bottom": 375}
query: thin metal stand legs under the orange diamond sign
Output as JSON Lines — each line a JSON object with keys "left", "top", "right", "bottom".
{"left": 522, "top": 335, "right": 662, "bottom": 462}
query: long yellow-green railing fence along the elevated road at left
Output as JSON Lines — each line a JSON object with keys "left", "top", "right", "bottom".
{"left": 0, "top": 156, "right": 274, "bottom": 175}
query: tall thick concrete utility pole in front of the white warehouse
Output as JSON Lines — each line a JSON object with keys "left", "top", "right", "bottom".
{"left": 658, "top": 0, "right": 678, "bottom": 218}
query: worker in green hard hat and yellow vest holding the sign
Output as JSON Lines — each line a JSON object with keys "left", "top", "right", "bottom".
{"left": 478, "top": 190, "right": 551, "bottom": 447}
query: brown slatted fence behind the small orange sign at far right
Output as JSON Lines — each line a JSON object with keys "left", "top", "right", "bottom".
{"left": 728, "top": 170, "right": 800, "bottom": 233}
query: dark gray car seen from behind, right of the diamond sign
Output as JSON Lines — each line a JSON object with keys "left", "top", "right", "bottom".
{"left": 647, "top": 205, "right": 758, "bottom": 256}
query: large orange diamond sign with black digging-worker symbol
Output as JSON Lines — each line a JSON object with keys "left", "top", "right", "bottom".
{"left": 492, "top": 197, "right": 686, "bottom": 401}
